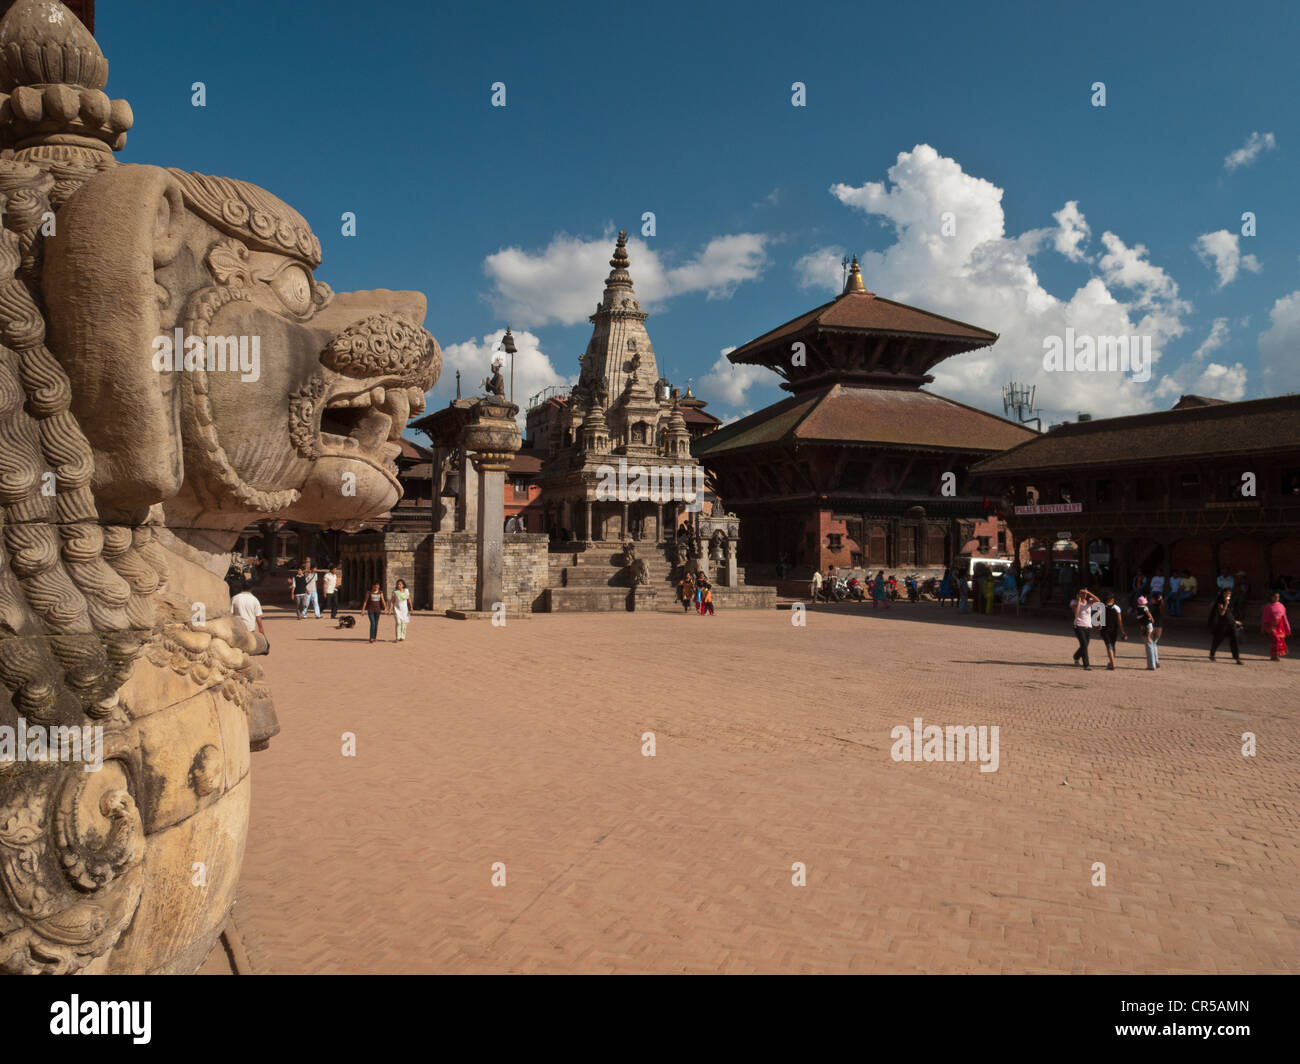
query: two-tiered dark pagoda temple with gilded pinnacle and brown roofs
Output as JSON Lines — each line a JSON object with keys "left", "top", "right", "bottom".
{"left": 693, "top": 256, "right": 1036, "bottom": 570}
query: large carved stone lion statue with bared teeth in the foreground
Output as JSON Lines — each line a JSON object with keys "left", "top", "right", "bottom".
{"left": 0, "top": 0, "right": 441, "bottom": 973}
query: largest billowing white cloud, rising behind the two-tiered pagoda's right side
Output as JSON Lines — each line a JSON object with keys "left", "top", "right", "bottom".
{"left": 816, "top": 144, "right": 1191, "bottom": 420}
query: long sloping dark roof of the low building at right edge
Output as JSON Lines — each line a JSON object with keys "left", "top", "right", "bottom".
{"left": 974, "top": 395, "right": 1300, "bottom": 473}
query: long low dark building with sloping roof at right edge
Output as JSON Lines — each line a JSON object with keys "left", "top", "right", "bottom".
{"left": 972, "top": 395, "right": 1300, "bottom": 605}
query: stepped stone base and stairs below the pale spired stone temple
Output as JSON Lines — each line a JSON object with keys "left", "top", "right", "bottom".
{"left": 542, "top": 542, "right": 776, "bottom": 613}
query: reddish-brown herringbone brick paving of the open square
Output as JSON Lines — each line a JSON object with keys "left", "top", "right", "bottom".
{"left": 228, "top": 605, "right": 1300, "bottom": 973}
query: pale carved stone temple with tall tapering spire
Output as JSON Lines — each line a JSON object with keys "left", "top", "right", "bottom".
{"left": 528, "top": 232, "right": 716, "bottom": 542}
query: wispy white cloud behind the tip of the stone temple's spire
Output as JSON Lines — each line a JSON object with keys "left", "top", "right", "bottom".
{"left": 484, "top": 233, "right": 768, "bottom": 328}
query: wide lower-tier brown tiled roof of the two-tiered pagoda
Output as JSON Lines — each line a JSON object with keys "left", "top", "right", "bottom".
{"left": 694, "top": 384, "right": 1034, "bottom": 459}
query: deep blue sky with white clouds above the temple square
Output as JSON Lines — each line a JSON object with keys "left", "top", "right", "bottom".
{"left": 104, "top": 0, "right": 1300, "bottom": 418}
